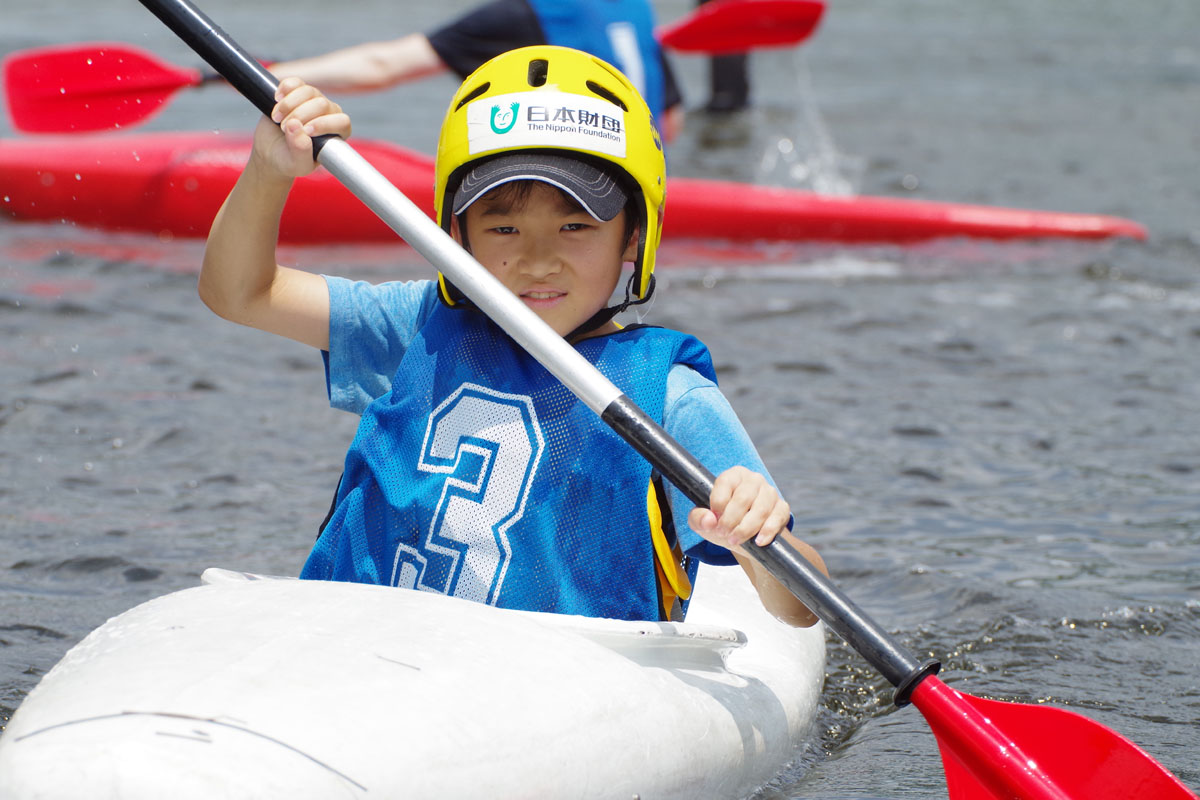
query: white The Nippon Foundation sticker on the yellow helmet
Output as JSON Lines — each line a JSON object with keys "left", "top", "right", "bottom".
{"left": 467, "top": 90, "right": 625, "bottom": 158}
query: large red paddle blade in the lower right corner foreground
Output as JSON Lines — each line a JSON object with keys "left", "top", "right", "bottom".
{"left": 912, "top": 678, "right": 1196, "bottom": 800}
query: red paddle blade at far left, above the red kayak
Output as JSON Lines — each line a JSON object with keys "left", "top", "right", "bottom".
{"left": 4, "top": 43, "right": 202, "bottom": 133}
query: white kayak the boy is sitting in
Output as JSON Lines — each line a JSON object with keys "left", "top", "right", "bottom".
{"left": 0, "top": 565, "right": 824, "bottom": 800}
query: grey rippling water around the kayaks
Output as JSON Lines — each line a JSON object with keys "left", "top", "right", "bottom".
{"left": 0, "top": 0, "right": 1200, "bottom": 800}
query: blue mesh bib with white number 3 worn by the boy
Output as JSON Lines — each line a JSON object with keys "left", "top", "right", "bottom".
{"left": 300, "top": 305, "right": 715, "bottom": 619}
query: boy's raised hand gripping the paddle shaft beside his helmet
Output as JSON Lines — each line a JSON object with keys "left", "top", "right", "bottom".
{"left": 254, "top": 78, "right": 350, "bottom": 179}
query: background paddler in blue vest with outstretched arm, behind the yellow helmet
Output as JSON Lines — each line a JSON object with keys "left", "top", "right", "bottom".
{"left": 270, "top": 0, "right": 684, "bottom": 142}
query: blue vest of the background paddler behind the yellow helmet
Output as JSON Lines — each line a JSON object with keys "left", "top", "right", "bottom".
{"left": 526, "top": 0, "right": 665, "bottom": 127}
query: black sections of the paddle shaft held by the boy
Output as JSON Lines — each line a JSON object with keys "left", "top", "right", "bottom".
{"left": 140, "top": 0, "right": 940, "bottom": 705}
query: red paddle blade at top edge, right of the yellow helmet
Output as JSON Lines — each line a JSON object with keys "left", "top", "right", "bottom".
{"left": 659, "top": 0, "right": 824, "bottom": 53}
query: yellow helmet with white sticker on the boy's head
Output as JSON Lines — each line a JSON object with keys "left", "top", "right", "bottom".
{"left": 433, "top": 46, "right": 666, "bottom": 306}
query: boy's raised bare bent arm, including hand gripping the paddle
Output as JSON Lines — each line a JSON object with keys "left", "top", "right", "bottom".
{"left": 198, "top": 78, "right": 350, "bottom": 350}
